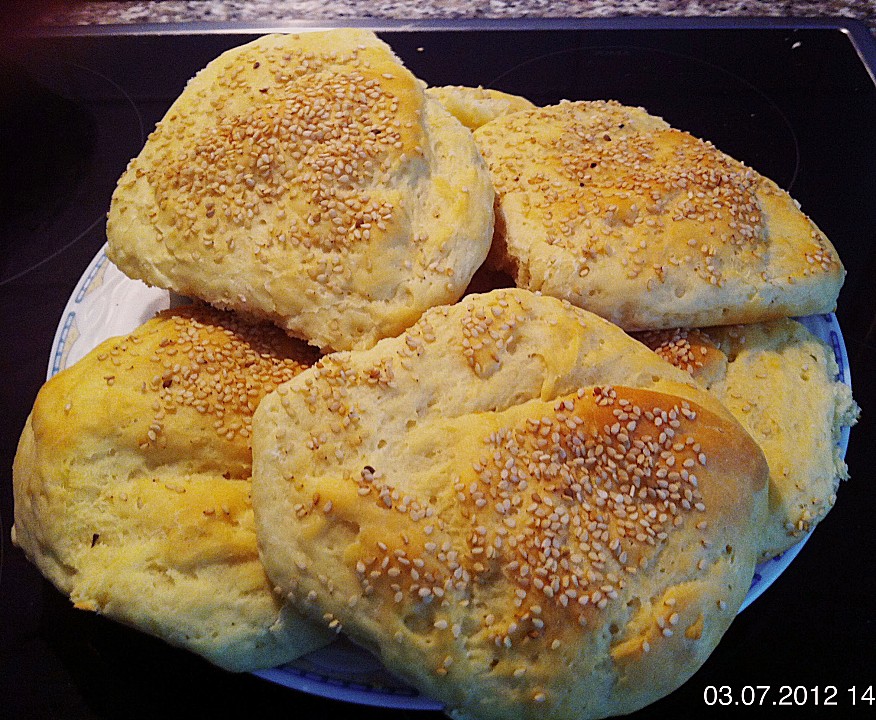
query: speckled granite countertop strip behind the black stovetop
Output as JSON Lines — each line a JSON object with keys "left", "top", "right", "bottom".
{"left": 30, "top": 0, "right": 876, "bottom": 29}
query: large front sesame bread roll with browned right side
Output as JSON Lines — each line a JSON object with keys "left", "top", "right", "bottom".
{"left": 253, "top": 289, "right": 767, "bottom": 720}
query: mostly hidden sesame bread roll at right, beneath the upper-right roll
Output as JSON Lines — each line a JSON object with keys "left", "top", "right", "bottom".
{"left": 638, "top": 319, "right": 860, "bottom": 560}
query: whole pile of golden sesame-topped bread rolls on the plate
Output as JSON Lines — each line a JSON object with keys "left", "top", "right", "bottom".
{"left": 13, "top": 29, "right": 858, "bottom": 719}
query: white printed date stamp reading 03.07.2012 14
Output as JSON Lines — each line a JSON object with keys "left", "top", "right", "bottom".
{"left": 703, "top": 685, "right": 876, "bottom": 708}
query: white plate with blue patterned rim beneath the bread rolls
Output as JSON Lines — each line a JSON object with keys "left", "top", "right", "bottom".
{"left": 48, "top": 248, "right": 851, "bottom": 710}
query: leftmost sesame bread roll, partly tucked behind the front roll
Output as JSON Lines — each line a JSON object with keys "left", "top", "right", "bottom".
{"left": 13, "top": 307, "right": 329, "bottom": 671}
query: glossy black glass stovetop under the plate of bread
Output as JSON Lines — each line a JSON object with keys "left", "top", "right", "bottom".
{"left": 0, "top": 20, "right": 876, "bottom": 718}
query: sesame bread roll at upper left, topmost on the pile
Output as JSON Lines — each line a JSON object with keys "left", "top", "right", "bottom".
{"left": 107, "top": 29, "right": 494, "bottom": 350}
